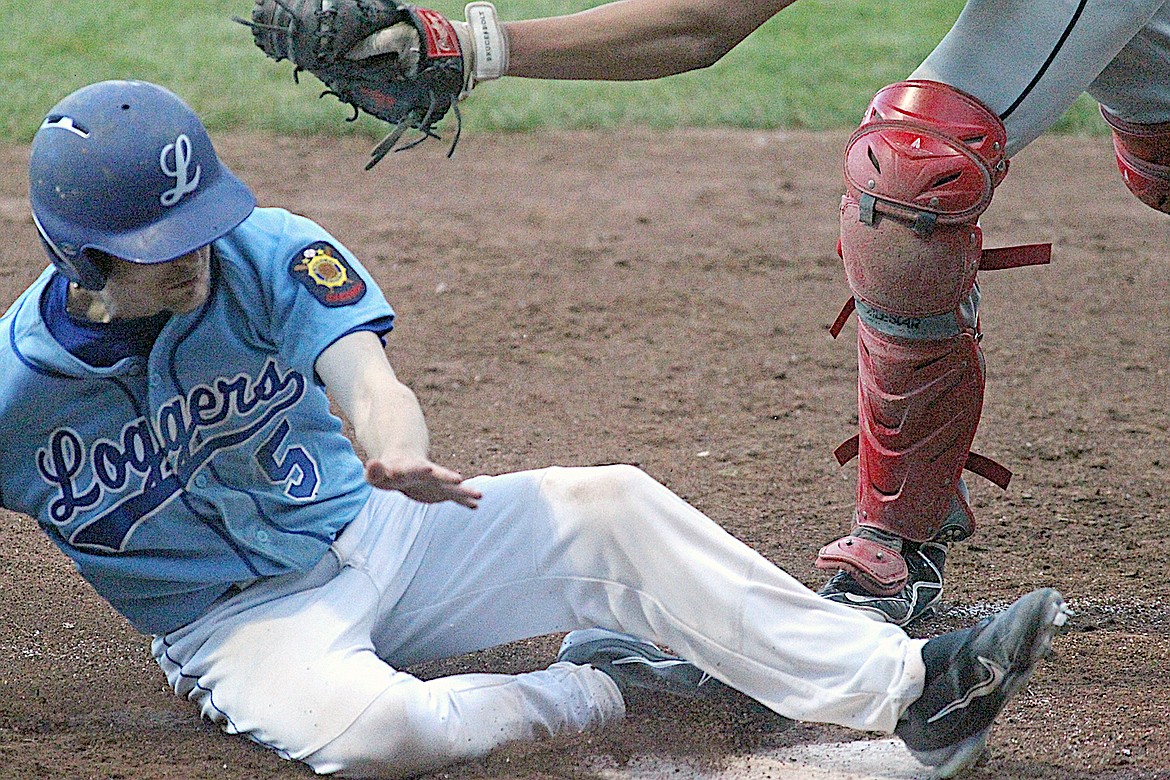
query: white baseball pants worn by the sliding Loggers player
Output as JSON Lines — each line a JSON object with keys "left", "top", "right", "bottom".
{"left": 153, "top": 465, "right": 924, "bottom": 776}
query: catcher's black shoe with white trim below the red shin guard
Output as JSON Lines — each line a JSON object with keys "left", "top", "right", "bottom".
{"left": 819, "top": 541, "right": 947, "bottom": 627}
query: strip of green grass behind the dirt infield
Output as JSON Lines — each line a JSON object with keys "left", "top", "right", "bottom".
{"left": 0, "top": 0, "right": 1101, "bottom": 140}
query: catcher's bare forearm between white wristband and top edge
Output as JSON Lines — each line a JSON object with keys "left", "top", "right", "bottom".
{"left": 504, "top": 0, "right": 794, "bottom": 81}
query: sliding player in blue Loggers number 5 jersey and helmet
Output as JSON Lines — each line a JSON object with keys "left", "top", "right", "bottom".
{"left": 0, "top": 82, "right": 1068, "bottom": 776}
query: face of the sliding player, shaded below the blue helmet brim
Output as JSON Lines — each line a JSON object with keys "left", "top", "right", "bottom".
{"left": 102, "top": 246, "right": 212, "bottom": 319}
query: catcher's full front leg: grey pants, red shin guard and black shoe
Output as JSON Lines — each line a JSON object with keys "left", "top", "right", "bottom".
{"left": 818, "top": 0, "right": 1164, "bottom": 624}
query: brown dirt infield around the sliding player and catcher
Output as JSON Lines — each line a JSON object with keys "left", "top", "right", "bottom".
{"left": 0, "top": 131, "right": 1170, "bottom": 780}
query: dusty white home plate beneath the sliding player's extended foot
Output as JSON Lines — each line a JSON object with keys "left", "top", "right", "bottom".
{"left": 596, "top": 739, "right": 934, "bottom": 780}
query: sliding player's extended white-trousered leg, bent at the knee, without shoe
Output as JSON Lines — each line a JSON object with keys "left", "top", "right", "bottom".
{"left": 355, "top": 465, "right": 921, "bottom": 741}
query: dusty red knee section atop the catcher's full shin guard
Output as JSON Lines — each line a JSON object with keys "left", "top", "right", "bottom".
{"left": 841, "top": 81, "right": 1007, "bottom": 317}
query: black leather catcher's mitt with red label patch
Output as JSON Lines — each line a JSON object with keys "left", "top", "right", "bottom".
{"left": 235, "top": 0, "right": 469, "bottom": 171}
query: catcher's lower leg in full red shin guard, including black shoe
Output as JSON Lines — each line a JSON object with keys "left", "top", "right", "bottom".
{"left": 817, "top": 81, "right": 1007, "bottom": 624}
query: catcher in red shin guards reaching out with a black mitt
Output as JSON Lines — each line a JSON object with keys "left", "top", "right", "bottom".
{"left": 246, "top": 0, "right": 1170, "bottom": 626}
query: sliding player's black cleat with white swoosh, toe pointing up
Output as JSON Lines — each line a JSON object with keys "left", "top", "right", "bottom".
{"left": 894, "top": 588, "right": 1073, "bottom": 778}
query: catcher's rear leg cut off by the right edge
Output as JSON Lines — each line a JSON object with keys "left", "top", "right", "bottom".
{"left": 1089, "top": 4, "right": 1170, "bottom": 212}
